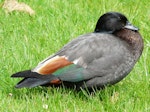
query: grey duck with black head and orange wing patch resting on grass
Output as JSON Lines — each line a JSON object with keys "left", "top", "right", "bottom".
{"left": 11, "top": 12, "right": 144, "bottom": 90}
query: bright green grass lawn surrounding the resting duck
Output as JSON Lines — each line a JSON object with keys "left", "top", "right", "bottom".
{"left": 0, "top": 0, "right": 150, "bottom": 112}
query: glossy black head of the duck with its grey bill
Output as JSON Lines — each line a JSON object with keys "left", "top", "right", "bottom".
{"left": 94, "top": 12, "right": 138, "bottom": 33}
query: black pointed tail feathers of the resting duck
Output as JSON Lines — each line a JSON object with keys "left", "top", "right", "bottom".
{"left": 11, "top": 70, "right": 59, "bottom": 88}
